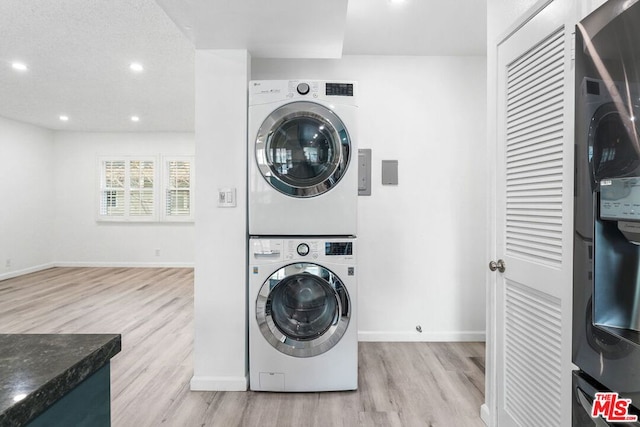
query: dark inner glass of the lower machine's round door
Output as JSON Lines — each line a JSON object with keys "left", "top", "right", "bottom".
{"left": 271, "top": 274, "right": 338, "bottom": 340}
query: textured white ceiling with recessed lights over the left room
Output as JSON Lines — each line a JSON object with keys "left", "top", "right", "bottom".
{"left": 0, "top": 0, "right": 194, "bottom": 131}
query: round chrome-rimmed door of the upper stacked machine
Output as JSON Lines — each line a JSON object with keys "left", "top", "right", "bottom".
{"left": 255, "top": 102, "right": 351, "bottom": 197}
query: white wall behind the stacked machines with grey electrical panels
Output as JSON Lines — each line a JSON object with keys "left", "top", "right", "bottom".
{"left": 251, "top": 56, "right": 488, "bottom": 341}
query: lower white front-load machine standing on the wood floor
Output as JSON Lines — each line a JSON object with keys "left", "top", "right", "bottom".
{"left": 249, "top": 237, "right": 358, "bottom": 392}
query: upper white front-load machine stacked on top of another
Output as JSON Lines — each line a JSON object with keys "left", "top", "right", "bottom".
{"left": 248, "top": 80, "right": 358, "bottom": 236}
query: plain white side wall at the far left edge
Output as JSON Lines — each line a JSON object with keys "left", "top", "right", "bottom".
{"left": 0, "top": 117, "right": 54, "bottom": 280}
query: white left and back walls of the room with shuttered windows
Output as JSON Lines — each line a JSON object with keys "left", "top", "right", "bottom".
{"left": 0, "top": 117, "right": 195, "bottom": 280}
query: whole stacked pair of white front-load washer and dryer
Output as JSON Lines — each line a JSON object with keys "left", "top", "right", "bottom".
{"left": 248, "top": 80, "right": 358, "bottom": 392}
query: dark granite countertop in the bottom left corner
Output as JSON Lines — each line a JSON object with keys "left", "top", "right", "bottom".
{"left": 0, "top": 334, "right": 121, "bottom": 427}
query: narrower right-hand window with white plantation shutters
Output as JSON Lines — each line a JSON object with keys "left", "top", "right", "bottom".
{"left": 164, "top": 157, "right": 193, "bottom": 221}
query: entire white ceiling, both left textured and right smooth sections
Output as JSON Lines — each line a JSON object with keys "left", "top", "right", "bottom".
{"left": 0, "top": 0, "right": 486, "bottom": 132}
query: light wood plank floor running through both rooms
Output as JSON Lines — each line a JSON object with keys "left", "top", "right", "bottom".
{"left": 0, "top": 268, "right": 484, "bottom": 427}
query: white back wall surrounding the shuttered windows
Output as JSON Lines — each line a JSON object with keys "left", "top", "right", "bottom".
{"left": 49, "top": 132, "right": 195, "bottom": 267}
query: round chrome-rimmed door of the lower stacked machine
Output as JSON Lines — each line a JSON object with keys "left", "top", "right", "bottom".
{"left": 256, "top": 263, "right": 351, "bottom": 357}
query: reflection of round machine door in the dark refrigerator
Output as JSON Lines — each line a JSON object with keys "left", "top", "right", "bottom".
{"left": 589, "top": 102, "right": 640, "bottom": 183}
